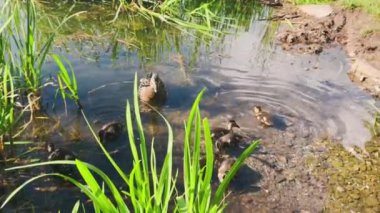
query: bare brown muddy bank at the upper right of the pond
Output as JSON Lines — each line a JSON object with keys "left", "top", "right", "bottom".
{"left": 274, "top": 4, "right": 380, "bottom": 97}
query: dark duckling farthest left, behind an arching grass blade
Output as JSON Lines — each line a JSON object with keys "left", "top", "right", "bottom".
{"left": 47, "top": 143, "right": 77, "bottom": 174}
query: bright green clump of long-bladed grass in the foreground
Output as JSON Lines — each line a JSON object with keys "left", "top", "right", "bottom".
{"left": 1, "top": 74, "right": 258, "bottom": 212}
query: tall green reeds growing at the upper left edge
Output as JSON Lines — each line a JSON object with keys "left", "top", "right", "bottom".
{"left": 1, "top": 0, "right": 80, "bottom": 111}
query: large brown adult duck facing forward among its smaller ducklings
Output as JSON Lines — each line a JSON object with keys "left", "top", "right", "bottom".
{"left": 139, "top": 73, "right": 167, "bottom": 104}
